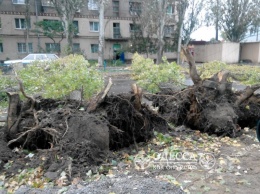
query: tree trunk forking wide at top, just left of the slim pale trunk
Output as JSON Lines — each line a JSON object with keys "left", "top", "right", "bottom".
{"left": 51, "top": 0, "right": 84, "bottom": 54}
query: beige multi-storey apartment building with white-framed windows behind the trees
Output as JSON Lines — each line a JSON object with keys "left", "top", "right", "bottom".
{"left": 0, "top": 0, "right": 176, "bottom": 62}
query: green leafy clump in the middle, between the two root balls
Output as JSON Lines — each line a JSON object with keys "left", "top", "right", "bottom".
{"left": 131, "top": 53, "right": 184, "bottom": 93}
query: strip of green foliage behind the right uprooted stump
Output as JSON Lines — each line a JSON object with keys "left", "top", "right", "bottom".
{"left": 199, "top": 61, "right": 260, "bottom": 85}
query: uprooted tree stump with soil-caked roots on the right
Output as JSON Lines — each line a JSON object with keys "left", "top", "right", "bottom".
{"left": 153, "top": 47, "right": 260, "bottom": 137}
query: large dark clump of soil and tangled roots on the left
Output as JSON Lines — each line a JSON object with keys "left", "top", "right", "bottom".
{"left": 1, "top": 94, "right": 169, "bottom": 177}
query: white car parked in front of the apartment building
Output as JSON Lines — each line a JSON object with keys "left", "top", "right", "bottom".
{"left": 4, "top": 53, "right": 59, "bottom": 65}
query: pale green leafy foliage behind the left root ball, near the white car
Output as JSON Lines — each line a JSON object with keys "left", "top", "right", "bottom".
{"left": 18, "top": 55, "right": 103, "bottom": 99}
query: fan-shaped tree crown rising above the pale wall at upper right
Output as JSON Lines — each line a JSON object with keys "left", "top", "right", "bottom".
{"left": 207, "top": 0, "right": 260, "bottom": 42}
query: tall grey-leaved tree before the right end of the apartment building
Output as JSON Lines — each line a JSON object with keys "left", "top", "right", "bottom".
{"left": 132, "top": 0, "right": 176, "bottom": 64}
